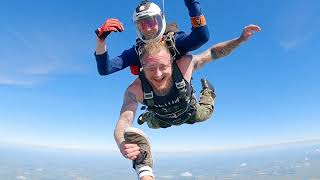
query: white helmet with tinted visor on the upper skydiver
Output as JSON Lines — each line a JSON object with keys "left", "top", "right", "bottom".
{"left": 133, "top": 1, "right": 166, "bottom": 43}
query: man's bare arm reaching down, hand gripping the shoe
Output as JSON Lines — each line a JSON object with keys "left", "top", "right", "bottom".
{"left": 114, "top": 85, "right": 140, "bottom": 160}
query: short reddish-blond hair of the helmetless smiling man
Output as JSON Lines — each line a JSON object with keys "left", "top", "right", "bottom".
{"left": 140, "top": 41, "right": 171, "bottom": 62}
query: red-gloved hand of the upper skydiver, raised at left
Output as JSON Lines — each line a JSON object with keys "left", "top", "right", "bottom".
{"left": 95, "top": 18, "right": 124, "bottom": 40}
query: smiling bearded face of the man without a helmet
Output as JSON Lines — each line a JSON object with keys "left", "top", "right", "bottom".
{"left": 142, "top": 49, "right": 172, "bottom": 91}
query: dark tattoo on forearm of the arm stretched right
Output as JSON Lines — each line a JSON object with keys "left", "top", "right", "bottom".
{"left": 211, "top": 39, "right": 240, "bottom": 59}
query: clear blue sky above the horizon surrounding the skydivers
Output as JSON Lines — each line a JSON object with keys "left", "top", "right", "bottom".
{"left": 0, "top": 0, "right": 320, "bottom": 151}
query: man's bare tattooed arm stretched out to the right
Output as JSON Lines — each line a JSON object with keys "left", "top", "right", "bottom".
{"left": 193, "top": 25, "right": 261, "bottom": 70}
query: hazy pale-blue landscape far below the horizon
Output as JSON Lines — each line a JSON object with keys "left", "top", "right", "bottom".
{"left": 0, "top": 141, "right": 320, "bottom": 180}
